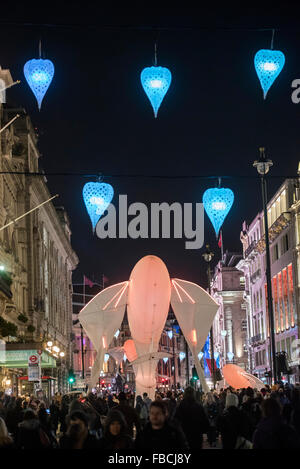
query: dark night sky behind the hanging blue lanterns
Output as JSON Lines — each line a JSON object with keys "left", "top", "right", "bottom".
{"left": 0, "top": 2, "right": 300, "bottom": 285}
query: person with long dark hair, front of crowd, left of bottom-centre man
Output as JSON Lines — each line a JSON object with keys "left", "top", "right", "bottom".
{"left": 99, "top": 409, "right": 133, "bottom": 450}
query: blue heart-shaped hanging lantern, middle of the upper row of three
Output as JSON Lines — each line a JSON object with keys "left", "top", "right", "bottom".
{"left": 141, "top": 66, "right": 172, "bottom": 117}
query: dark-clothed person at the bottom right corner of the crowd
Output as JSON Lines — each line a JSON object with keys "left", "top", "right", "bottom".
{"left": 253, "top": 398, "right": 300, "bottom": 450}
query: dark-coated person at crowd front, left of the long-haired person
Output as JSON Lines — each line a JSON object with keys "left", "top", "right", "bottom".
{"left": 59, "top": 410, "right": 99, "bottom": 449}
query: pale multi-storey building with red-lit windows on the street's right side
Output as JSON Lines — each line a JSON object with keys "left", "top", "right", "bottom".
{"left": 237, "top": 174, "right": 300, "bottom": 383}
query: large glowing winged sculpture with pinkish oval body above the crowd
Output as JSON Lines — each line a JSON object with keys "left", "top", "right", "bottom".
{"left": 79, "top": 255, "right": 219, "bottom": 399}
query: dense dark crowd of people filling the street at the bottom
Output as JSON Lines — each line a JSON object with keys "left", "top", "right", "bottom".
{"left": 0, "top": 384, "right": 300, "bottom": 452}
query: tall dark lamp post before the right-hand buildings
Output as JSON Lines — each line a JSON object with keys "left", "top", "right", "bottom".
{"left": 253, "top": 147, "right": 277, "bottom": 383}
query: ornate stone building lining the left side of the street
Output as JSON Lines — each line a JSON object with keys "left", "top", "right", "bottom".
{"left": 0, "top": 69, "right": 78, "bottom": 395}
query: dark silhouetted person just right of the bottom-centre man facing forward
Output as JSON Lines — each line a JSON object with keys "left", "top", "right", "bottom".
{"left": 174, "top": 387, "right": 209, "bottom": 450}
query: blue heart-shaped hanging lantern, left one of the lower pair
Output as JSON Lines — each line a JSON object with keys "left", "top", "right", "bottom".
{"left": 82, "top": 182, "right": 114, "bottom": 232}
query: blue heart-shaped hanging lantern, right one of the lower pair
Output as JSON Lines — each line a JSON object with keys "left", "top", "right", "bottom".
{"left": 202, "top": 187, "right": 234, "bottom": 236}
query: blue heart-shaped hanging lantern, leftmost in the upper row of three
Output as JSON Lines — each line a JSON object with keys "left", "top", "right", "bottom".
{"left": 24, "top": 59, "right": 54, "bottom": 110}
